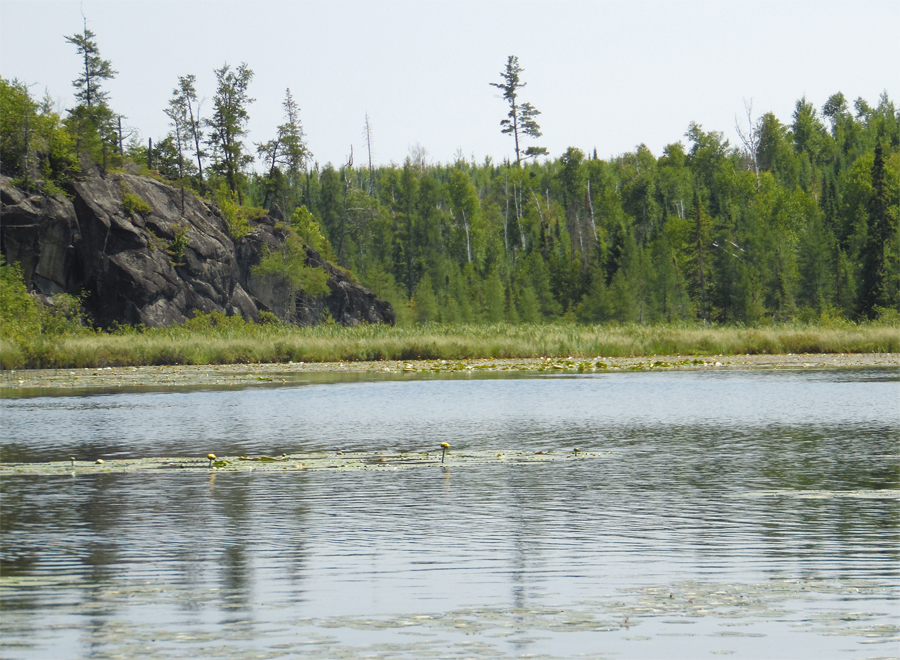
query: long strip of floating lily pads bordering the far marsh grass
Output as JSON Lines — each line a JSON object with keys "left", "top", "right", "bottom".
{"left": 0, "top": 353, "right": 900, "bottom": 396}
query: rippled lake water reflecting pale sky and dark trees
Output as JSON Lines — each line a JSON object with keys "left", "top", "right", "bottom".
{"left": 0, "top": 370, "right": 900, "bottom": 659}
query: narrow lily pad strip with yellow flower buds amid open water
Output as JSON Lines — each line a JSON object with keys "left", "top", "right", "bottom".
{"left": 0, "top": 449, "right": 615, "bottom": 477}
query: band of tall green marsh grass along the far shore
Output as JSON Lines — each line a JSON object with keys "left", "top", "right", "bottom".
{"left": 0, "top": 319, "right": 900, "bottom": 369}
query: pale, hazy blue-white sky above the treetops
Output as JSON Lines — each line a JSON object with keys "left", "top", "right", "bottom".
{"left": 0, "top": 0, "right": 900, "bottom": 170}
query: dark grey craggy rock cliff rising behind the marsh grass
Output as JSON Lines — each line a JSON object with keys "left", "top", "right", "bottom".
{"left": 0, "top": 174, "right": 394, "bottom": 327}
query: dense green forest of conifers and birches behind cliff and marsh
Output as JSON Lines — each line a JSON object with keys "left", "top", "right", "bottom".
{"left": 0, "top": 29, "right": 900, "bottom": 325}
